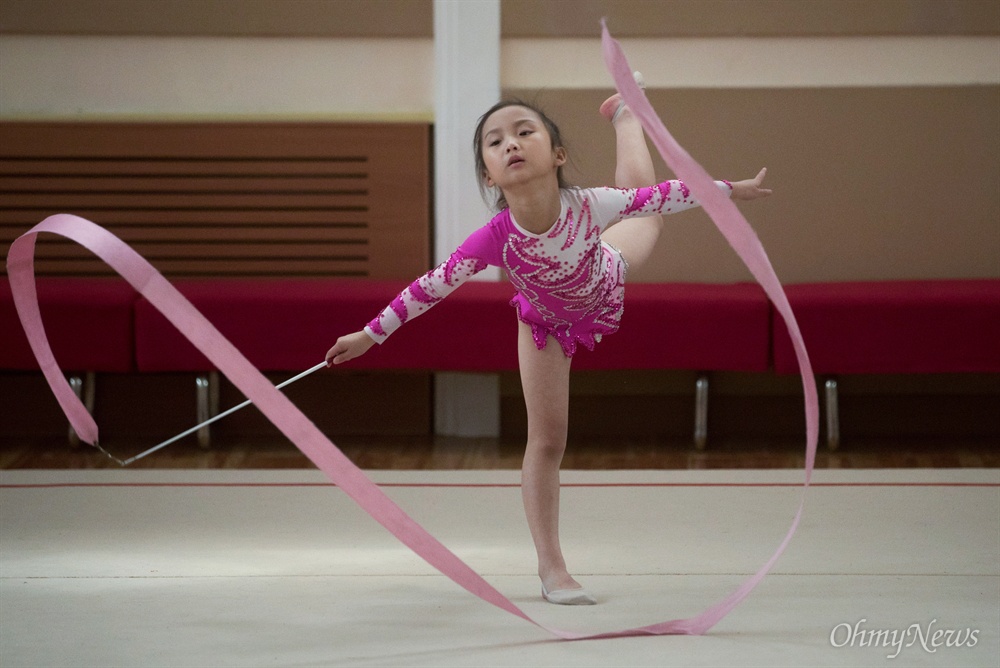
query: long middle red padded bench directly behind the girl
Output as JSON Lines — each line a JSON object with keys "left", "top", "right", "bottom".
{"left": 136, "top": 279, "right": 770, "bottom": 447}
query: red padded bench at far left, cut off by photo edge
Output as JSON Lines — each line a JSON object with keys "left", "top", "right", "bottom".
{"left": 0, "top": 276, "right": 138, "bottom": 442}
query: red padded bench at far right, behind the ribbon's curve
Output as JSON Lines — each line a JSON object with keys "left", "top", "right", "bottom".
{"left": 773, "top": 279, "right": 1000, "bottom": 448}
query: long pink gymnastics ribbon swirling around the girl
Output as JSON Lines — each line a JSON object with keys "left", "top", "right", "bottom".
{"left": 7, "top": 27, "right": 819, "bottom": 640}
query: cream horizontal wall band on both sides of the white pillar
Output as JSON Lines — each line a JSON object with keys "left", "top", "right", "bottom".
{"left": 0, "top": 35, "right": 1000, "bottom": 121}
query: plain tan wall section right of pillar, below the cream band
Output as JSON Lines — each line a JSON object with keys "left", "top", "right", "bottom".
{"left": 524, "top": 86, "right": 1000, "bottom": 282}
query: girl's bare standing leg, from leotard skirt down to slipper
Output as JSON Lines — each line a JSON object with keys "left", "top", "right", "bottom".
{"left": 518, "top": 323, "right": 580, "bottom": 592}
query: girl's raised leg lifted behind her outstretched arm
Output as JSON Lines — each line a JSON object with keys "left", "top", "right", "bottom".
{"left": 601, "top": 94, "right": 663, "bottom": 270}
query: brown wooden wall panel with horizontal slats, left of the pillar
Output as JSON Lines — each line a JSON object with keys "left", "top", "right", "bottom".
{"left": 0, "top": 123, "right": 431, "bottom": 279}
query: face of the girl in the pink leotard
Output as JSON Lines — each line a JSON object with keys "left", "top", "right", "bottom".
{"left": 482, "top": 105, "right": 566, "bottom": 190}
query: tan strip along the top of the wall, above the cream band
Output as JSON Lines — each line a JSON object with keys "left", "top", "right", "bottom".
{"left": 0, "top": 0, "right": 1000, "bottom": 38}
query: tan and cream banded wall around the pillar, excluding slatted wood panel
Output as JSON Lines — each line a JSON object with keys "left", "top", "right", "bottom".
{"left": 0, "top": 0, "right": 1000, "bottom": 282}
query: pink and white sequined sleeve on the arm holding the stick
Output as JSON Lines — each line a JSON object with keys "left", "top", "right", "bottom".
{"left": 365, "top": 225, "right": 503, "bottom": 344}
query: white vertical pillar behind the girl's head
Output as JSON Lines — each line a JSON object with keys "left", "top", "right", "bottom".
{"left": 434, "top": 0, "right": 500, "bottom": 436}
